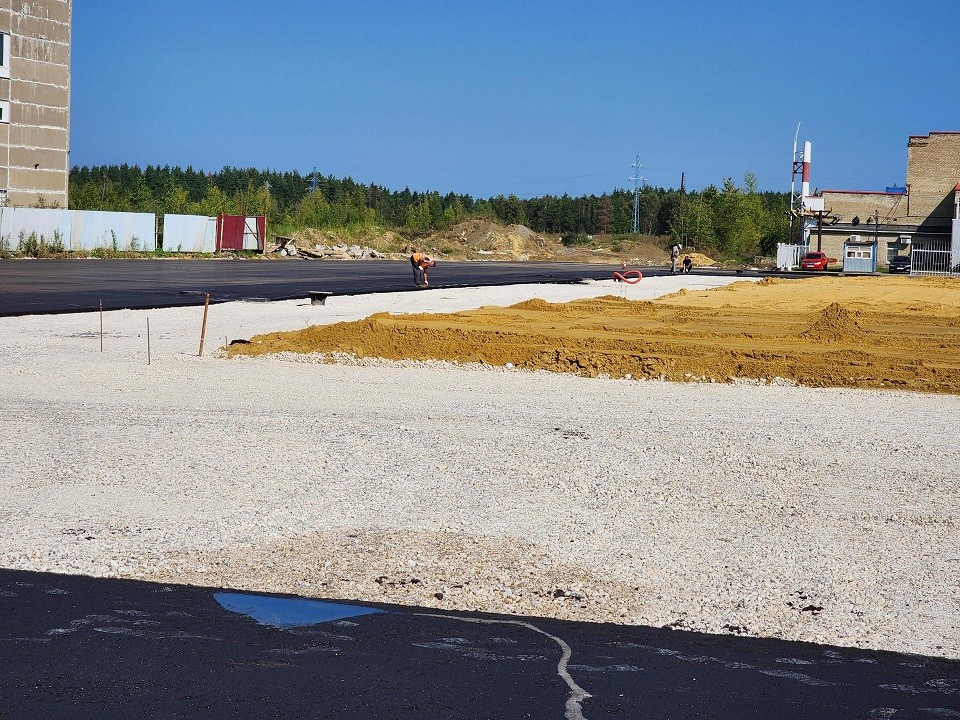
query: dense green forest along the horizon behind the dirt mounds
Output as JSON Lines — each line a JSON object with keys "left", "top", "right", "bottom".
{"left": 70, "top": 165, "right": 789, "bottom": 257}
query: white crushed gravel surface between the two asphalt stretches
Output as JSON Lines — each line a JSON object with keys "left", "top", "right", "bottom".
{"left": 0, "top": 276, "right": 960, "bottom": 657}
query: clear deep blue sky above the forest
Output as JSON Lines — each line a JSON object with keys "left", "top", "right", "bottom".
{"left": 71, "top": 0, "right": 960, "bottom": 197}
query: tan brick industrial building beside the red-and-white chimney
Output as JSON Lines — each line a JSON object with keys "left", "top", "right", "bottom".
{"left": 808, "top": 132, "right": 960, "bottom": 274}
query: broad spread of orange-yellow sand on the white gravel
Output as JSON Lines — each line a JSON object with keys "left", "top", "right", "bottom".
{"left": 230, "top": 278, "right": 960, "bottom": 393}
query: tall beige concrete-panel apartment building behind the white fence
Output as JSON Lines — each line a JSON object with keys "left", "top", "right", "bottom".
{"left": 0, "top": 0, "right": 73, "bottom": 208}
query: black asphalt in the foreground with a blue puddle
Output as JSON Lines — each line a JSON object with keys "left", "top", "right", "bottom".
{"left": 0, "top": 570, "right": 960, "bottom": 720}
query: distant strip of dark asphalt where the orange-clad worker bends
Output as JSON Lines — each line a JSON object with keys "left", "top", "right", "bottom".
{"left": 0, "top": 259, "right": 780, "bottom": 316}
